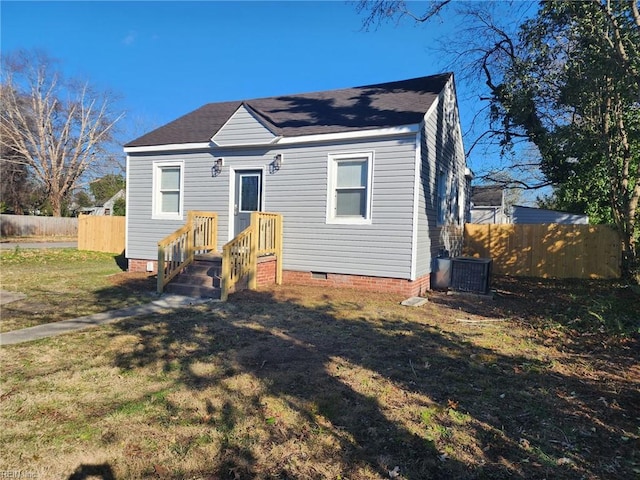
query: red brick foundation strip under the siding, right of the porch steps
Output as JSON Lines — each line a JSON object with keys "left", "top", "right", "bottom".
{"left": 282, "top": 270, "right": 430, "bottom": 297}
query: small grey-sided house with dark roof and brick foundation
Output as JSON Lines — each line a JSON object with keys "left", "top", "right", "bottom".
{"left": 124, "top": 73, "right": 471, "bottom": 295}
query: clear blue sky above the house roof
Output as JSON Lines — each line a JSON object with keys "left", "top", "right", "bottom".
{"left": 0, "top": 1, "right": 520, "bottom": 180}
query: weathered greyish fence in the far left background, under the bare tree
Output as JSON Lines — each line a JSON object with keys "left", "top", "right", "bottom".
{"left": 0, "top": 214, "right": 78, "bottom": 237}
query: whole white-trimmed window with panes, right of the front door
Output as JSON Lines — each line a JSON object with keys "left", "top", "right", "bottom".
{"left": 327, "top": 152, "right": 373, "bottom": 224}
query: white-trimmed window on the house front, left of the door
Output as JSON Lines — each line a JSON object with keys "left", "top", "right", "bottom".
{"left": 153, "top": 162, "right": 184, "bottom": 220}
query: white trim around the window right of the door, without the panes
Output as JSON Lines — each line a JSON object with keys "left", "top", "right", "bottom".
{"left": 327, "top": 151, "right": 373, "bottom": 225}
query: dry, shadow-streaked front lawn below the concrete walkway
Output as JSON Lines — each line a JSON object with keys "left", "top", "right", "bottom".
{"left": 0, "top": 279, "right": 640, "bottom": 480}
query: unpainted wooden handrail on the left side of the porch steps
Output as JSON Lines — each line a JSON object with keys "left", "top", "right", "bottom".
{"left": 157, "top": 210, "right": 218, "bottom": 293}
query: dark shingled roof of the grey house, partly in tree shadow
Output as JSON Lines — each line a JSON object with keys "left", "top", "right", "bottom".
{"left": 125, "top": 73, "right": 452, "bottom": 147}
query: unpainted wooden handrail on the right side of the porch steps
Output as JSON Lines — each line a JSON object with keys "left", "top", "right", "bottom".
{"left": 221, "top": 212, "right": 282, "bottom": 301}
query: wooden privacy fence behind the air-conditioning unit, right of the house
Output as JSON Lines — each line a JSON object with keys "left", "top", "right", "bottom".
{"left": 464, "top": 224, "right": 622, "bottom": 278}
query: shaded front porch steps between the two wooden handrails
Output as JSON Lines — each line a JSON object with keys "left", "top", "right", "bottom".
{"left": 165, "top": 254, "right": 222, "bottom": 298}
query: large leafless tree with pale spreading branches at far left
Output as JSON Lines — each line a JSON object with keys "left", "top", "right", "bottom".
{"left": 0, "top": 51, "right": 123, "bottom": 216}
